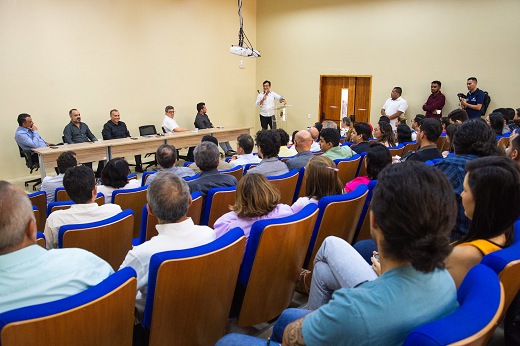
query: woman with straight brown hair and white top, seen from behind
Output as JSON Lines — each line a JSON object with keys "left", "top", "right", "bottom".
{"left": 291, "top": 155, "right": 343, "bottom": 213}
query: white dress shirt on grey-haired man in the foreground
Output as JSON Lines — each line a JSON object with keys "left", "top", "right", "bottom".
{"left": 119, "top": 217, "right": 216, "bottom": 314}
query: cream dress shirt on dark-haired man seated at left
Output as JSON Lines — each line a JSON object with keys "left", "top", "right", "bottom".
{"left": 43, "top": 203, "right": 122, "bottom": 249}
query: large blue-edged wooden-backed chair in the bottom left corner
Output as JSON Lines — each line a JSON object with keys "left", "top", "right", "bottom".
{"left": 0, "top": 268, "right": 136, "bottom": 346}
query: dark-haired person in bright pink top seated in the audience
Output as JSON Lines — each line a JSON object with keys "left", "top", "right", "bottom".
{"left": 345, "top": 143, "right": 390, "bottom": 192}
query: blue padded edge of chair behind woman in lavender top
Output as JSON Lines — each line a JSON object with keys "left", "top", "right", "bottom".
{"left": 238, "top": 203, "right": 318, "bottom": 287}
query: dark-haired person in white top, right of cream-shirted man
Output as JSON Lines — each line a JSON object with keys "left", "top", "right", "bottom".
{"left": 97, "top": 157, "right": 141, "bottom": 204}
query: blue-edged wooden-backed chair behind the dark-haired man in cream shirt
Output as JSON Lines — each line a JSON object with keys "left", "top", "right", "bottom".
{"left": 58, "top": 209, "right": 134, "bottom": 270}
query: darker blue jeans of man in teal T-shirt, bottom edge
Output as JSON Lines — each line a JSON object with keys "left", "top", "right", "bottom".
{"left": 215, "top": 309, "right": 311, "bottom": 346}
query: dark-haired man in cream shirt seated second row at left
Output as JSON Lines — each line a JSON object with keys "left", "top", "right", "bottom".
{"left": 40, "top": 166, "right": 122, "bottom": 249}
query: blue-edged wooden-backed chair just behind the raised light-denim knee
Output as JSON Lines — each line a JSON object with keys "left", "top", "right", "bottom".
{"left": 303, "top": 185, "right": 368, "bottom": 271}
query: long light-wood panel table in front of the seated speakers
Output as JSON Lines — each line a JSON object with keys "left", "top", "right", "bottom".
{"left": 32, "top": 126, "right": 253, "bottom": 180}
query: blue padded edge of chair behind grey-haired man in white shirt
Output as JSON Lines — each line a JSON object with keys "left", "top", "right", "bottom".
{"left": 143, "top": 227, "right": 244, "bottom": 329}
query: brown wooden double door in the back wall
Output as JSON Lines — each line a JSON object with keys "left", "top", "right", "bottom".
{"left": 319, "top": 76, "right": 372, "bottom": 125}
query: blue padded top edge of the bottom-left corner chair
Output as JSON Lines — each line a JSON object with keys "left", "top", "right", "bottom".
{"left": 0, "top": 267, "right": 136, "bottom": 344}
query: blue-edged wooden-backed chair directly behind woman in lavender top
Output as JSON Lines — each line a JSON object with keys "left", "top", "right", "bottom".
{"left": 231, "top": 203, "right": 318, "bottom": 327}
